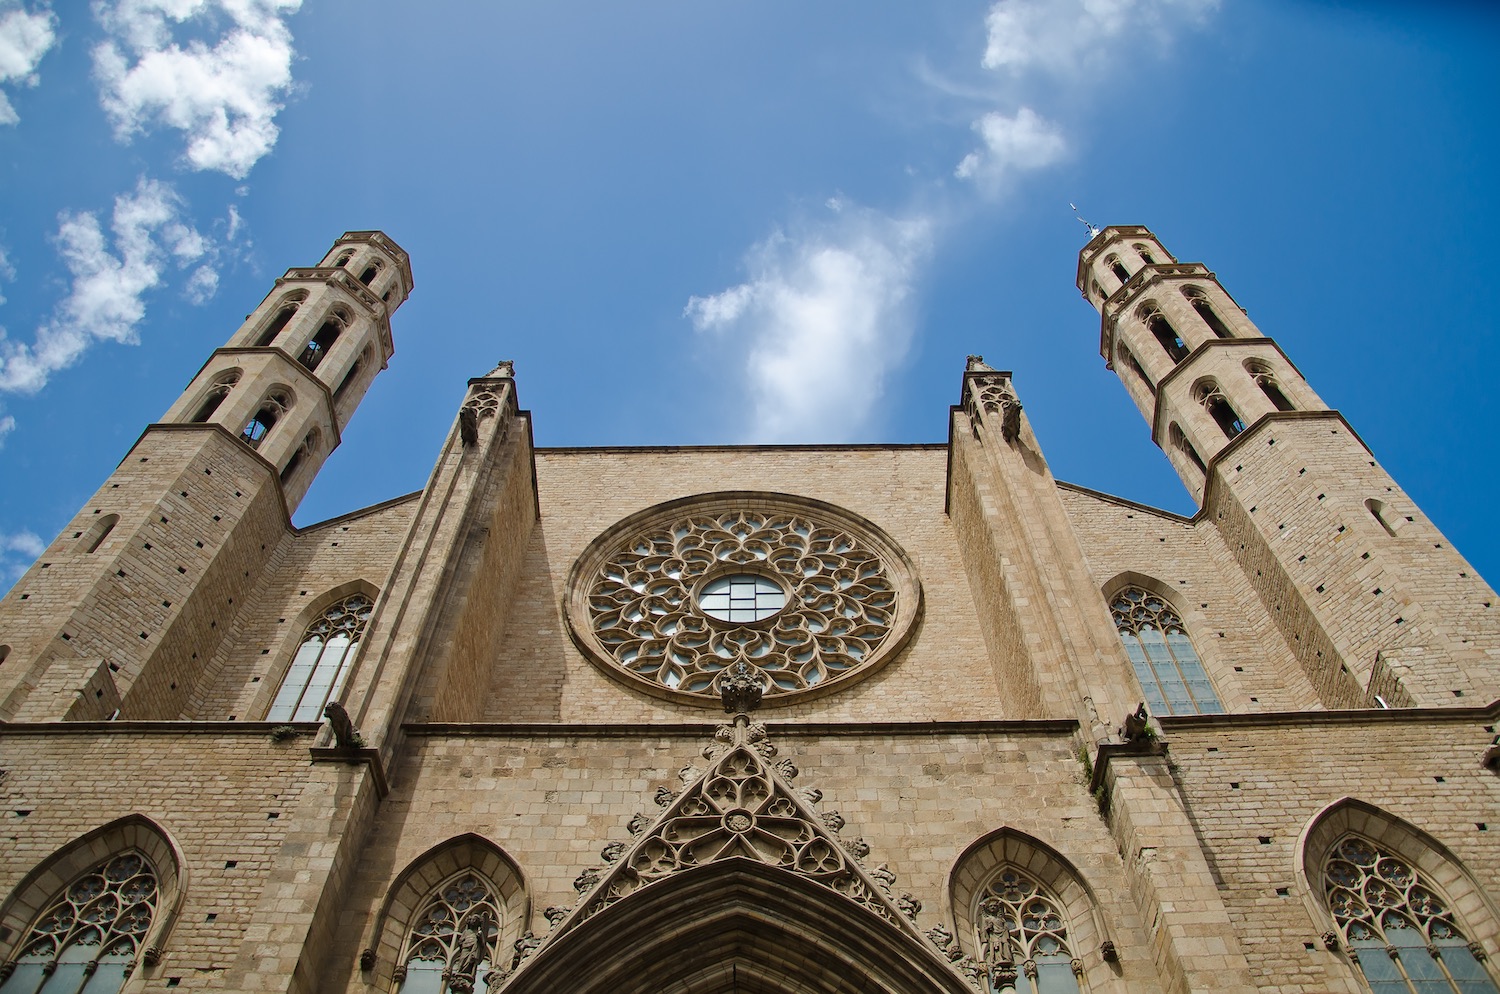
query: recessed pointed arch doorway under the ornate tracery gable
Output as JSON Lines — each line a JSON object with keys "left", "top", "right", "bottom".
{"left": 506, "top": 858, "right": 974, "bottom": 994}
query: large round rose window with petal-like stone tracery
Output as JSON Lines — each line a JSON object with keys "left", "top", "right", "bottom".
{"left": 569, "top": 493, "right": 921, "bottom": 703}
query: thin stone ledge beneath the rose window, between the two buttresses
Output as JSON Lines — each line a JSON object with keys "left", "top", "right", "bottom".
{"left": 401, "top": 715, "right": 1079, "bottom": 739}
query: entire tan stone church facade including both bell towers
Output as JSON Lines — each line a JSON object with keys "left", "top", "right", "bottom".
{"left": 0, "top": 226, "right": 1500, "bottom": 994}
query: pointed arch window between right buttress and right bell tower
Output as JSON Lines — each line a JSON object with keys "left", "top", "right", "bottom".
{"left": 1110, "top": 586, "right": 1224, "bottom": 715}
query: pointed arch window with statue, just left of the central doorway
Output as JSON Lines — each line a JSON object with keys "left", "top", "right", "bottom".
{"left": 396, "top": 870, "right": 500, "bottom": 994}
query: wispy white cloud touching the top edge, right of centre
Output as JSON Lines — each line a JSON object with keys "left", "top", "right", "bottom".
{"left": 984, "top": 0, "right": 1218, "bottom": 76}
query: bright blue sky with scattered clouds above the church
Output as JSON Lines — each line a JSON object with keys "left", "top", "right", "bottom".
{"left": 0, "top": 0, "right": 1500, "bottom": 589}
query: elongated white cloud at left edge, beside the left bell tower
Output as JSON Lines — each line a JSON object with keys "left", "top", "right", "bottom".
{"left": 0, "top": 178, "right": 218, "bottom": 393}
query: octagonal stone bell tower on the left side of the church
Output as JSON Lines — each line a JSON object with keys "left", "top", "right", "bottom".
{"left": 0, "top": 231, "right": 413, "bottom": 721}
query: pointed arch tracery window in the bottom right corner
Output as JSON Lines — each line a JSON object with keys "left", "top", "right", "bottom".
{"left": 1323, "top": 835, "right": 1500, "bottom": 994}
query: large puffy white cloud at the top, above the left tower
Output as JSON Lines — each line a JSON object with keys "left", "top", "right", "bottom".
{"left": 93, "top": 0, "right": 302, "bottom": 178}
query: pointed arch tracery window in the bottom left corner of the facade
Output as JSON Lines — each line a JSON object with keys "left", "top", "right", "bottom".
{"left": 0, "top": 850, "right": 159, "bottom": 994}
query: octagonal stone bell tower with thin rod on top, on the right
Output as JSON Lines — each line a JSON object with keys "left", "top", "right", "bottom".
{"left": 1077, "top": 225, "right": 1500, "bottom": 708}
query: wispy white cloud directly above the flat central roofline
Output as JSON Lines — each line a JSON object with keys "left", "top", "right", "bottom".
{"left": 683, "top": 201, "right": 935, "bottom": 442}
